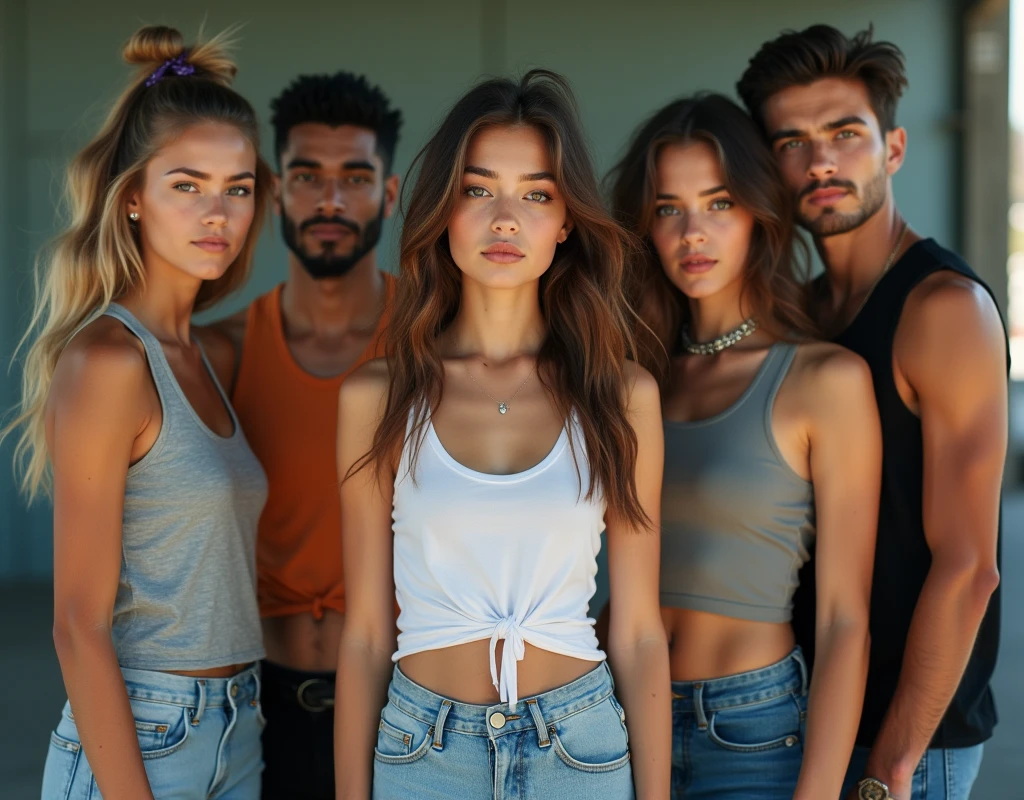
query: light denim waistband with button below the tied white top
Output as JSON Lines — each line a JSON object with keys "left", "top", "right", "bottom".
{"left": 387, "top": 662, "right": 614, "bottom": 738}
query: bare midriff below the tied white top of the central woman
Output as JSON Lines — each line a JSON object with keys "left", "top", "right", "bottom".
{"left": 398, "top": 639, "right": 599, "bottom": 706}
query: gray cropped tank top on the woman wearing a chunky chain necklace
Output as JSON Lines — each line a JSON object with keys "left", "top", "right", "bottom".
{"left": 660, "top": 342, "right": 815, "bottom": 623}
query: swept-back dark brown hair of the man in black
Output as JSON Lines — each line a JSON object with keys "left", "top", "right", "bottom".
{"left": 736, "top": 25, "right": 907, "bottom": 133}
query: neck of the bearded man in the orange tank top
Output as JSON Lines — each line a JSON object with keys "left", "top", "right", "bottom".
{"left": 281, "top": 249, "right": 384, "bottom": 332}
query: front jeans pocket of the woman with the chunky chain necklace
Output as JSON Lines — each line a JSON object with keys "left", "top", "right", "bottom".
{"left": 708, "top": 693, "right": 803, "bottom": 753}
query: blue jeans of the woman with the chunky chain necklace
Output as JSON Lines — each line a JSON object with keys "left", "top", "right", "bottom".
{"left": 672, "top": 647, "right": 807, "bottom": 800}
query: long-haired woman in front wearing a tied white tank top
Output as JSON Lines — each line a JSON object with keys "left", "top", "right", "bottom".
{"left": 335, "top": 71, "right": 670, "bottom": 800}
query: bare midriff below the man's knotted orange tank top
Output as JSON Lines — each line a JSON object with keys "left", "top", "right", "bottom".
{"left": 262, "top": 608, "right": 345, "bottom": 672}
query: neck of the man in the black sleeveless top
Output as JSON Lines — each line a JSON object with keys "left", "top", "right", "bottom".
{"left": 814, "top": 193, "right": 909, "bottom": 299}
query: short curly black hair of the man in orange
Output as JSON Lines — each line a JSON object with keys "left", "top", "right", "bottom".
{"left": 270, "top": 72, "right": 401, "bottom": 172}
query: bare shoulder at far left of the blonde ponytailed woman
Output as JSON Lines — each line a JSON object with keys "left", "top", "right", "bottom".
{"left": 50, "top": 317, "right": 152, "bottom": 410}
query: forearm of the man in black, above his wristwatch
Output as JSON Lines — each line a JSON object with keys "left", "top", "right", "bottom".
{"left": 867, "top": 562, "right": 998, "bottom": 783}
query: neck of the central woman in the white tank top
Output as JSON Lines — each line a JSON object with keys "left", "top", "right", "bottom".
{"left": 445, "top": 276, "right": 547, "bottom": 363}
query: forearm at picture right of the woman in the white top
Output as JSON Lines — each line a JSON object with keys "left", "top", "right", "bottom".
{"left": 609, "top": 633, "right": 672, "bottom": 800}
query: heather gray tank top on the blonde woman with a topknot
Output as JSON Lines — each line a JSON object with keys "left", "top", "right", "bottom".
{"left": 105, "top": 303, "right": 266, "bottom": 671}
